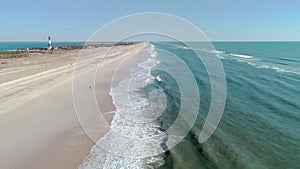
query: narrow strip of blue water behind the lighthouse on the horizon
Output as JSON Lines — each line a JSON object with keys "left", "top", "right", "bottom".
{"left": 0, "top": 41, "right": 84, "bottom": 51}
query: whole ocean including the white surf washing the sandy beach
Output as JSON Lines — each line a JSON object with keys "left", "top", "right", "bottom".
{"left": 0, "top": 42, "right": 300, "bottom": 169}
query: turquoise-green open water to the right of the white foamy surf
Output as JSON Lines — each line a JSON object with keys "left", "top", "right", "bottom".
{"left": 154, "top": 42, "right": 300, "bottom": 169}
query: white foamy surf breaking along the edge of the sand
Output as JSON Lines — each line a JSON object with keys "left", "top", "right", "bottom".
{"left": 79, "top": 45, "right": 167, "bottom": 169}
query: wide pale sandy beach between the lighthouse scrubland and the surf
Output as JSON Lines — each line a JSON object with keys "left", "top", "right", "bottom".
{"left": 0, "top": 43, "right": 147, "bottom": 169}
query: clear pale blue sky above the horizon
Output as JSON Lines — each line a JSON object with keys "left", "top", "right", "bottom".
{"left": 0, "top": 0, "right": 300, "bottom": 41}
